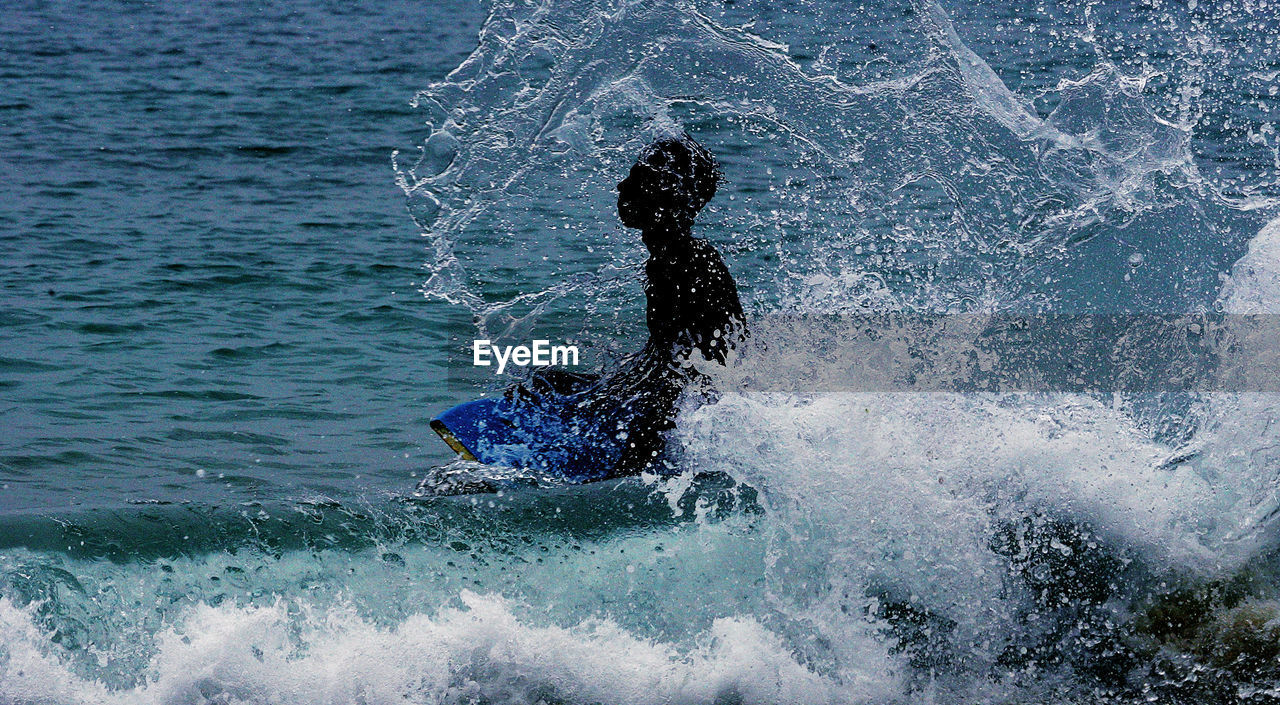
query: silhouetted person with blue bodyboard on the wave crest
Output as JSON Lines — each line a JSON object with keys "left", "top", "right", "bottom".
{"left": 422, "top": 134, "right": 746, "bottom": 494}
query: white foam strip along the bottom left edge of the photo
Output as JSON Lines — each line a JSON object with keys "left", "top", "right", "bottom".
{"left": 0, "top": 591, "right": 899, "bottom": 705}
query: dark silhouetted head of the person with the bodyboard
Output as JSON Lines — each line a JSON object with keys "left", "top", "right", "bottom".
{"left": 618, "top": 134, "right": 721, "bottom": 232}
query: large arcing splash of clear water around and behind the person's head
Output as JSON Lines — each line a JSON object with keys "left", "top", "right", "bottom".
{"left": 397, "top": 0, "right": 1269, "bottom": 332}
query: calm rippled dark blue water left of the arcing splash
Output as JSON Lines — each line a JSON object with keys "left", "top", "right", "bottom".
{"left": 0, "top": 3, "right": 484, "bottom": 511}
